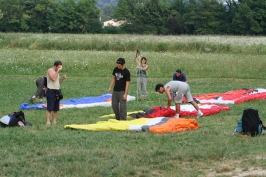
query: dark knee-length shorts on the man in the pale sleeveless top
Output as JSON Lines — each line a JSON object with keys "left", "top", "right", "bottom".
{"left": 46, "top": 88, "right": 60, "bottom": 111}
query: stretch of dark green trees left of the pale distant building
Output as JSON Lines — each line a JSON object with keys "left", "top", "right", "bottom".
{"left": 0, "top": 0, "right": 102, "bottom": 33}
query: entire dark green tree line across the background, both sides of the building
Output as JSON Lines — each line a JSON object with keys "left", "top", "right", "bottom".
{"left": 0, "top": 0, "right": 266, "bottom": 35}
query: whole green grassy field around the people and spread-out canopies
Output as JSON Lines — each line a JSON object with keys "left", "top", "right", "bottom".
{"left": 0, "top": 34, "right": 266, "bottom": 177}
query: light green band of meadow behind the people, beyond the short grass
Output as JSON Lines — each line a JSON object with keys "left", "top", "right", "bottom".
{"left": 0, "top": 49, "right": 266, "bottom": 80}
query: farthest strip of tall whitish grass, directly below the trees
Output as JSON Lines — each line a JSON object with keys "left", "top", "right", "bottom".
{"left": 0, "top": 33, "right": 266, "bottom": 54}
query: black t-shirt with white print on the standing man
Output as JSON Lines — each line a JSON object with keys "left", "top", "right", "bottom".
{"left": 113, "top": 67, "right": 130, "bottom": 91}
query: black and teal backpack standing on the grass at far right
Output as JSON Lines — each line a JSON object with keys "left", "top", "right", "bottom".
{"left": 235, "top": 108, "right": 266, "bottom": 136}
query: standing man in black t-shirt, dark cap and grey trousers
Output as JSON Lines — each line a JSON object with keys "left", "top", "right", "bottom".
{"left": 108, "top": 58, "right": 130, "bottom": 120}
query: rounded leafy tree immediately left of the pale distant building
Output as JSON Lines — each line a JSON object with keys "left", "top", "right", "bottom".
{"left": 47, "top": 0, "right": 102, "bottom": 33}
